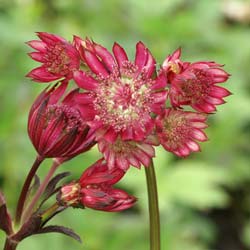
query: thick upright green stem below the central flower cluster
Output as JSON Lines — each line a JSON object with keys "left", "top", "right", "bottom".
{"left": 145, "top": 160, "right": 161, "bottom": 250}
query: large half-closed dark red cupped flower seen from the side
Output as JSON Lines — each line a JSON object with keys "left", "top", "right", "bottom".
{"left": 28, "top": 82, "right": 95, "bottom": 158}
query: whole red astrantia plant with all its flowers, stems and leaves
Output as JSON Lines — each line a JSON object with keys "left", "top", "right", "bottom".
{"left": 0, "top": 32, "right": 230, "bottom": 250}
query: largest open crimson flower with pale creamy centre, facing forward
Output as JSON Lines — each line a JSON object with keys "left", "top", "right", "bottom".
{"left": 74, "top": 40, "right": 167, "bottom": 142}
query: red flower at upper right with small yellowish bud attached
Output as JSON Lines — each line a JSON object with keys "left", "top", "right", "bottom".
{"left": 162, "top": 47, "right": 230, "bottom": 113}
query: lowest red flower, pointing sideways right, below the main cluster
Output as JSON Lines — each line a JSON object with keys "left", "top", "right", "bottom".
{"left": 58, "top": 159, "right": 136, "bottom": 212}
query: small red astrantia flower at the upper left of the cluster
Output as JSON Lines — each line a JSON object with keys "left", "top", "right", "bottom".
{"left": 27, "top": 32, "right": 80, "bottom": 82}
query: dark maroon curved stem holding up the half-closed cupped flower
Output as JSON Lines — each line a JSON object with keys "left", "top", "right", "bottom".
{"left": 15, "top": 155, "right": 44, "bottom": 223}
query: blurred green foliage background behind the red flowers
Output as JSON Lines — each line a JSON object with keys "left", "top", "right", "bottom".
{"left": 0, "top": 0, "right": 250, "bottom": 250}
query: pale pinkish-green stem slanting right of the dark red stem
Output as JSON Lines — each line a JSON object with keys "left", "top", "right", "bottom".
{"left": 23, "top": 159, "right": 61, "bottom": 222}
